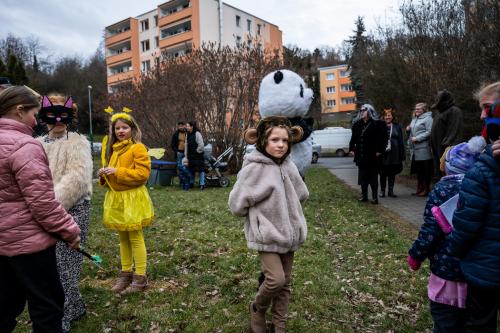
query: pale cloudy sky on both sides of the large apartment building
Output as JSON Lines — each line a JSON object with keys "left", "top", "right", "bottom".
{"left": 0, "top": 0, "right": 399, "bottom": 57}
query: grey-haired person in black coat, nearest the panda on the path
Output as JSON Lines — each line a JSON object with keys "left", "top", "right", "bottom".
{"left": 349, "top": 104, "right": 388, "bottom": 204}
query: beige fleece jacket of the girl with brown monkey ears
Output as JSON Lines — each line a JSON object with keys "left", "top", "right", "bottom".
{"left": 228, "top": 150, "right": 309, "bottom": 253}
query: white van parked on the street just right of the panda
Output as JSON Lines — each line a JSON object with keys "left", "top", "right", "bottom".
{"left": 312, "top": 127, "right": 352, "bottom": 157}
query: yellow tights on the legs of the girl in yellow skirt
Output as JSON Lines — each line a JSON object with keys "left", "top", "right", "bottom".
{"left": 118, "top": 230, "right": 147, "bottom": 275}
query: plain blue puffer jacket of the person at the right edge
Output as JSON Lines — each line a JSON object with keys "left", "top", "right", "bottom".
{"left": 447, "top": 146, "right": 500, "bottom": 289}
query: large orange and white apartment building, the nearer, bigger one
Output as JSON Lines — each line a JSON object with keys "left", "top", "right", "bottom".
{"left": 105, "top": 0, "right": 282, "bottom": 92}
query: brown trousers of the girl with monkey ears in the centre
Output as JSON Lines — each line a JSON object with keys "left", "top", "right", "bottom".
{"left": 254, "top": 252, "right": 294, "bottom": 329}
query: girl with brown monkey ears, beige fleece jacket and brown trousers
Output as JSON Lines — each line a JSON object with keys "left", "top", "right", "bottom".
{"left": 229, "top": 117, "right": 309, "bottom": 333}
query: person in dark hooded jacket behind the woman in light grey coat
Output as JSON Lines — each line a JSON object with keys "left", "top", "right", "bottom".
{"left": 431, "top": 90, "right": 464, "bottom": 178}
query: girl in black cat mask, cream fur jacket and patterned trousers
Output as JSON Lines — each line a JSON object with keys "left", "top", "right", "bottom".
{"left": 38, "top": 94, "right": 92, "bottom": 332}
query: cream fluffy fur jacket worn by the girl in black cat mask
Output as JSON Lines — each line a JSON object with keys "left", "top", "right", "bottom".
{"left": 38, "top": 132, "right": 93, "bottom": 210}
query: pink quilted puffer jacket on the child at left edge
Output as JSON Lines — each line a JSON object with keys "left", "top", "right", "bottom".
{"left": 0, "top": 118, "right": 80, "bottom": 257}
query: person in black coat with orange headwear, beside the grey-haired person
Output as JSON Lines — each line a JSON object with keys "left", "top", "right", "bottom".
{"left": 380, "top": 108, "right": 405, "bottom": 198}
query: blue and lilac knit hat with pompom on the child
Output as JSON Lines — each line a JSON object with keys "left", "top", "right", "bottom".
{"left": 445, "top": 136, "right": 486, "bottom": 175}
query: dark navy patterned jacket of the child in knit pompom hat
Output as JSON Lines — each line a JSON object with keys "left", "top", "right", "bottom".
{"left": 408, "top": 174, "right": 464, "bottom": 281}
